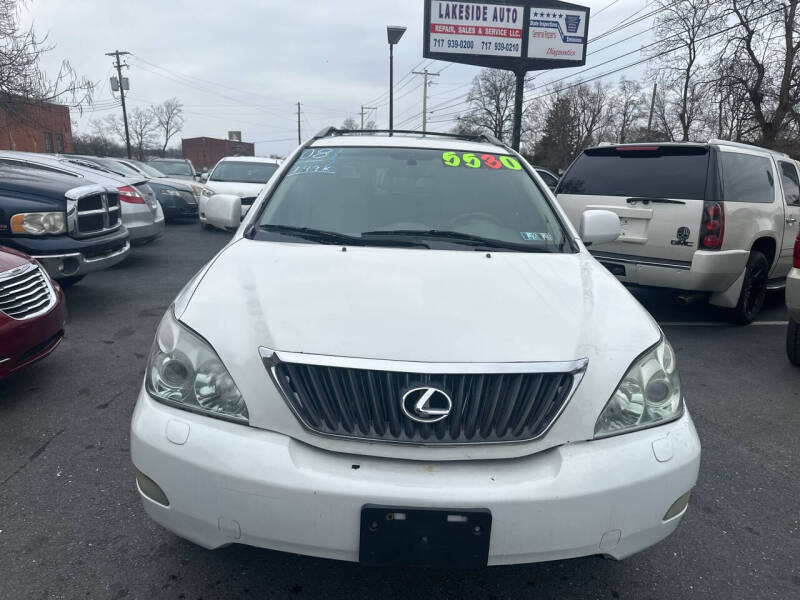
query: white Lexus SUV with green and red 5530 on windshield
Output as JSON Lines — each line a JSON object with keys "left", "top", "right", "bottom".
{"left": 131, "top": 129, "right": 700, "bottom": 567}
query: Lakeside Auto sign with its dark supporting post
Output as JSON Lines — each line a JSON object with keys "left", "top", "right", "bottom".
{"left": 422, "top": 0, "right": 589, "bottom": 151}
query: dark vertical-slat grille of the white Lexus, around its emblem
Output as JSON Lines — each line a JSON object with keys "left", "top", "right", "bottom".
{"left": 265, "top": 355, "right": 585, "bottom": 444}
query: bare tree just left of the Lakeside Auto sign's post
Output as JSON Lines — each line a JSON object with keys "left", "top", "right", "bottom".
{"left": 458, "top": 69, "right": 516, "bottom": 141}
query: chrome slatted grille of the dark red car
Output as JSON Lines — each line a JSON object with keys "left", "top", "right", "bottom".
{"left": 0, "top": 264, "right": 56, "bottom": 320}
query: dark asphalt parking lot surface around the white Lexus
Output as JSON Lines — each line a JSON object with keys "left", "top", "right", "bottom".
{"left": 0, "top": 223, "right": 800, "bottom": 600}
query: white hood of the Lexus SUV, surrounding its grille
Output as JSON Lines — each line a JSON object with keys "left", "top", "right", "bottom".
{"left": 176, "top": 239, "right": 661, "bottom": 459}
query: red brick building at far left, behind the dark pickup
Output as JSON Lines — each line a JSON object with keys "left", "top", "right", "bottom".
{"left": 0, "top": 102, "right": 73, "bottom": 154}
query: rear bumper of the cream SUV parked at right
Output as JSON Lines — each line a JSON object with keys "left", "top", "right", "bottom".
{"left": 592, "top": 250, "right": 750, "bottom": 293}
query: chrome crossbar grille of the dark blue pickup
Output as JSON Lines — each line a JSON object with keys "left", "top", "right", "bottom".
{"left": 67, "top": 186, "right": 122, "bottom": 238}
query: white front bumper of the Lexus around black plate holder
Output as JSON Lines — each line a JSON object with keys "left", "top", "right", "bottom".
{"left": 131, "top": 391, "right": 700, "bottom": 565}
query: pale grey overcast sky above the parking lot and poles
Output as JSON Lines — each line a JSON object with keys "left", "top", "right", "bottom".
{"left": 18, "top": 0, "right": 651, "bottom": 155}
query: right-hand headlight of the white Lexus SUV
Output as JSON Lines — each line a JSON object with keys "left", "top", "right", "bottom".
{"left": 594, "top": 339, "right": 683, "bottom": 438}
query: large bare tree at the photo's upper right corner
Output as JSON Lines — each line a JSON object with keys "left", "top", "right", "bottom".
{"left": 720, "top": 0, "right": 800, "bottom": 148}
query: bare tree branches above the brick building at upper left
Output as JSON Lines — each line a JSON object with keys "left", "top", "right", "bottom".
{"left": 0, "top": 0, "right": 93, "bottom": 121}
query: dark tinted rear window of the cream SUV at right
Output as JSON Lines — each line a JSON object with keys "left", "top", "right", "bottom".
{"left": 558, "top": 146, "right": 709, "bottom": 200}
